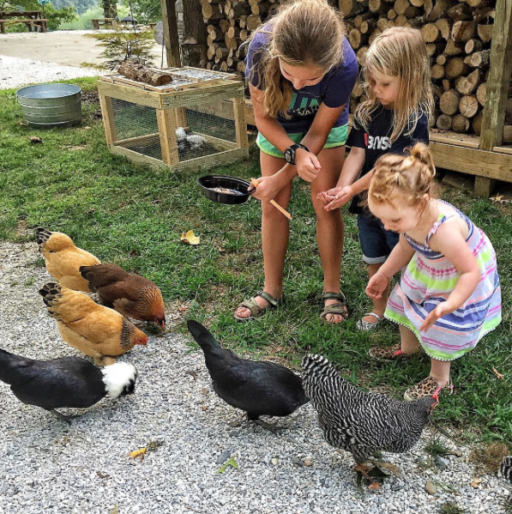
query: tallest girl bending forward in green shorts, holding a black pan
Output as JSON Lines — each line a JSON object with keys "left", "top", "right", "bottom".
{"left": 235, "top": 0, "right": 358, "bottom": 323}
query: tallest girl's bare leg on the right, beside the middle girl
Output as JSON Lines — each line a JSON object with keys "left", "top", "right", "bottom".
{"left": 311, "top": 146, "right": 345, "bottom": 323}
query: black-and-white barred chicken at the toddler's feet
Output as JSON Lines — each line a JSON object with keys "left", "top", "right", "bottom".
{"left": 302, "top": 355, "right": 437, "bottom": 489}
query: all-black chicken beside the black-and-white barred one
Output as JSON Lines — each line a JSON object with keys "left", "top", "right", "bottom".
{"left": 187, "top": 321, "right": 309, "bottom": 432}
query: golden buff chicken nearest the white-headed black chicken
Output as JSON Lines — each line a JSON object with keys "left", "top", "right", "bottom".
{"left": 39, "top": 282, "right": 148, "bottom": 366}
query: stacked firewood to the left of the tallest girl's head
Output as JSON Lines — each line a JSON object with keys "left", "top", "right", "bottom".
{"left": 200, "top": 0, "right": 278, "bottom": 76}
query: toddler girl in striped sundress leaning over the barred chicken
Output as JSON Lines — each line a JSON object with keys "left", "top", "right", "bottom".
{"left": 366, "top": 144, "right": 501, "bottom": 401}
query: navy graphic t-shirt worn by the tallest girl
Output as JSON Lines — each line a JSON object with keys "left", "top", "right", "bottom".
{"left": 245, "top": 27, "right": 359, "bottom": 134}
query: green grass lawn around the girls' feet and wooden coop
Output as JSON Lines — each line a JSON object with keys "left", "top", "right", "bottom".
{"left": 0, "top": 79, "right": 512, "bottom": 443}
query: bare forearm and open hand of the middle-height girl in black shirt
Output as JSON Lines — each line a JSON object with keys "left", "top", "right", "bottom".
{"left": 317, "top": 146, "right": 366, "bottom": 211}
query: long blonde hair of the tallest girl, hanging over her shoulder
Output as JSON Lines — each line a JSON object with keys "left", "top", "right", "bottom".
{"left": 249, "top": 0, "right": 345, "bottom": 118}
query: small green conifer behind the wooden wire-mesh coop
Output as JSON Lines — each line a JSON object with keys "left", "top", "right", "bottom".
{"left": 87, "top": 28, "right": 155, "bottom": 70}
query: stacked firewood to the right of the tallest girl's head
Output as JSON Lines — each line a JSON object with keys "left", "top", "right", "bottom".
{"left": 339, "top": 0, "right": 512, "bottom": 140}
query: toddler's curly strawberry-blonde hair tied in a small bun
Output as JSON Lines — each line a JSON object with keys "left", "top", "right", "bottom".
{"left": 368, "top": 143, "right": 437, "bottom": 206}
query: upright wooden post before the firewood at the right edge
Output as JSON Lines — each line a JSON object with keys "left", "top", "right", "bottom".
{"left": 475, "top": 0, "right": 512, "bottom": 196}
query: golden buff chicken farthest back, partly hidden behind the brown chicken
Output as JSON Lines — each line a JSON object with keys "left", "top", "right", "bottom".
{"left": 36, "top": 227, "right": 100, "bottom": 293}
